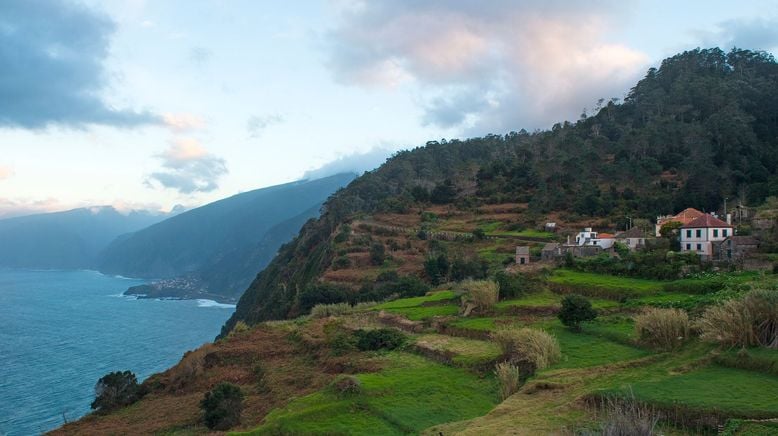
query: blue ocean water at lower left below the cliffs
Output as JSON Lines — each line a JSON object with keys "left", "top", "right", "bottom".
{"left": 0, "top": 270, "right": 234, "bottom": 436}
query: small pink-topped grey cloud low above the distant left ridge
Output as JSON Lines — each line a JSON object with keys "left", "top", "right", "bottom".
{"left": 146, "top": 138, "right": 227, "bottom": 194}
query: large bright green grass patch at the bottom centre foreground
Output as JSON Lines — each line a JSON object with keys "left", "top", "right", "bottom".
{"left": 239, "top": 352, "right": 497, "bottom": 435}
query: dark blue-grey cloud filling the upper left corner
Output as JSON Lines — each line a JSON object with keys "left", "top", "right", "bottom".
{"left": 0, "top": 0, "right": 159, "bottom": 129}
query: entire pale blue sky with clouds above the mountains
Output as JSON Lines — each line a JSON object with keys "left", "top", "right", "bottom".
{"left": 0, "top": 0, "right": 778, "bottom": 218}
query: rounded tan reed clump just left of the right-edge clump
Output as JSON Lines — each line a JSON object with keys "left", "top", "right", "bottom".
{"left": 635, "top": 309, "right": 689, "bottom": 351}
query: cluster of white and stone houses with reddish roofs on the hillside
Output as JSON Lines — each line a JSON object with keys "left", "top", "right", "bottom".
{"left": 516, "top": 208, "right": 773, "bottom": 269}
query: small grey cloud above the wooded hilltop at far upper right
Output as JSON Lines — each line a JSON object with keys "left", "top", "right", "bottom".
{"left": 698, "top": 18, "right": 778, "bottom": 52}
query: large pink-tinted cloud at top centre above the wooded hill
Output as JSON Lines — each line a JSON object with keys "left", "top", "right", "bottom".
{"left": 326, "top": 0, "right": 648, "bottom": 133}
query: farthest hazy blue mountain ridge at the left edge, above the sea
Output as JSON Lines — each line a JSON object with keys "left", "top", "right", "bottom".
{"left": 0, "top": 206, "right": 169, "bottom": 269}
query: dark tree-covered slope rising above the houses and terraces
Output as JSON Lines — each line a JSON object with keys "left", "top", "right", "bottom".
{"left": 222, "top": 49, "right": 778, "bottom": 334}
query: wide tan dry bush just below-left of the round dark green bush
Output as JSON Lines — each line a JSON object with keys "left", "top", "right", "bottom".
{"left": 491, "top": 327, "right": 562, "bottom": 372}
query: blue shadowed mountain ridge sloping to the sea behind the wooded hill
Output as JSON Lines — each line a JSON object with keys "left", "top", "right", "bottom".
{"left": 98, "top": 173, "right": 356, "bottom": 300}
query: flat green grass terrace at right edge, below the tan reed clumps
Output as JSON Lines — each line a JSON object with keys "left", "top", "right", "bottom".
{"left": 620, "top": 365, "right": 778, "bottom": 417}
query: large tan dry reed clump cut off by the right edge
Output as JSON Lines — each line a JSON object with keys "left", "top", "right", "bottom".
{"left": 696, "top": 290, "right": 778, "bottom": 348}
